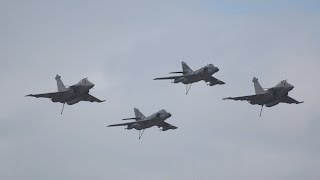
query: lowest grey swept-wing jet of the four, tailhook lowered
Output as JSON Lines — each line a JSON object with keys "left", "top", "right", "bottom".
{"left": 107, "top": 108, "right": 177, "bottom": 139}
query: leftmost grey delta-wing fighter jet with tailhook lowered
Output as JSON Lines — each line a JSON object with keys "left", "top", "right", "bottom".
{"left": 27, "top": 75, "right": 104, "bottom": 114}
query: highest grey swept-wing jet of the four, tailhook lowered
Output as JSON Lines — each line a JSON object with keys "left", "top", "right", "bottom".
{"left": 154, "top": 61, "right": 225, "bottom": 94}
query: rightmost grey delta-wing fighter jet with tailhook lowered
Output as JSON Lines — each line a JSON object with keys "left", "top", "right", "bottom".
{"left": 223, "top": 77, "right": 303, "bottom": 117}
